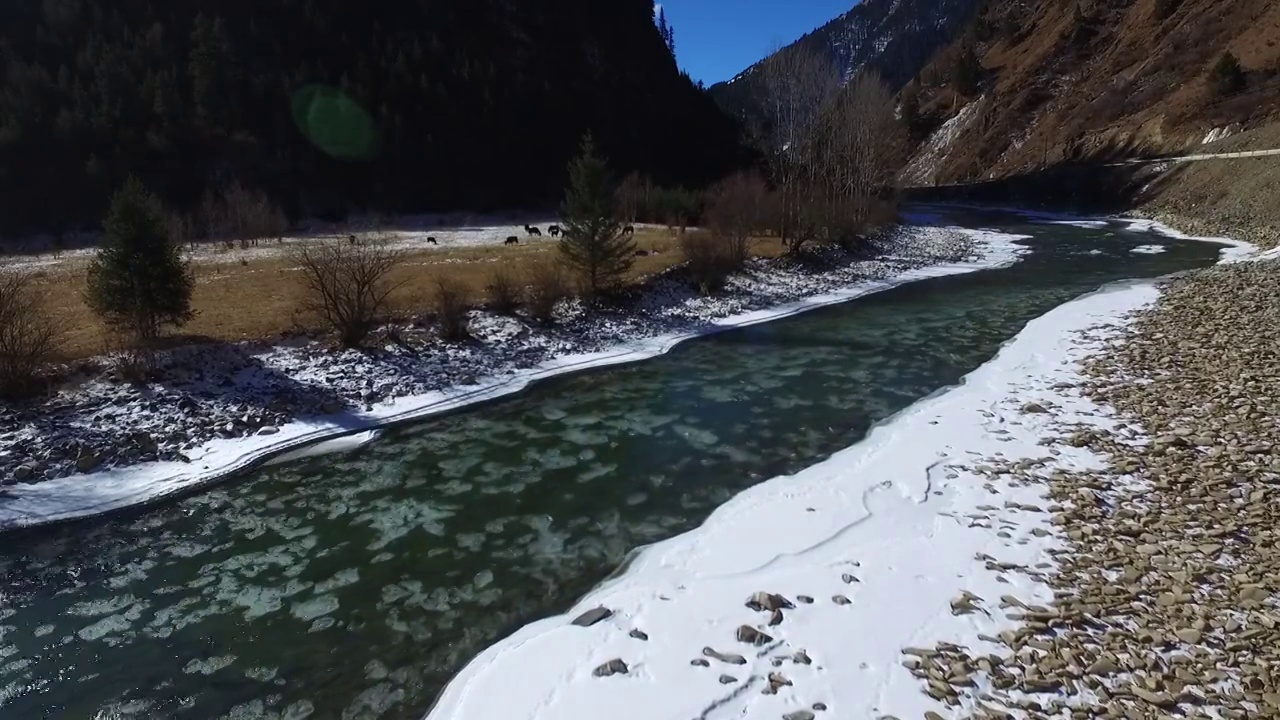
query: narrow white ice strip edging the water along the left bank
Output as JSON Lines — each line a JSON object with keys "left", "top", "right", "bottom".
{"left": 0, "top": 228, "right": 1025, "bottom": 533}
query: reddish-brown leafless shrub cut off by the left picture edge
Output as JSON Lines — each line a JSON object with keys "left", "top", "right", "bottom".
{"left": 0, "top": 269, "right": 58, "bottom": 398}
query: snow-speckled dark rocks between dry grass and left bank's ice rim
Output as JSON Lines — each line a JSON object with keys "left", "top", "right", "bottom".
{"left": 0, "top": 228, "right": 977, "bottom": 484}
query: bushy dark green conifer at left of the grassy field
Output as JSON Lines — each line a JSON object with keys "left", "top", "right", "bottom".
{"left": 86, "top": 178, "right": 195, "bottom": 342}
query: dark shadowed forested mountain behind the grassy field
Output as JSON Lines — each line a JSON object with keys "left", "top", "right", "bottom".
{"left": 0, "top": 0, "right": 737, "bottom": 233}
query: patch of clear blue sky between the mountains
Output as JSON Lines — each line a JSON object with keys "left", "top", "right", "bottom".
{"left": 658, "top": 0, "right": 856, "bottom": 86}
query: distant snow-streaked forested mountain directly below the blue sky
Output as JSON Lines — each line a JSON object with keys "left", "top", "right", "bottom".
{"left": 710, "top": 0, "right": 978, "bottom": 126}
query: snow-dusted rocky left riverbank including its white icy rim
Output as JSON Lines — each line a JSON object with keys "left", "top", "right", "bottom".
{"left": 0, "top": 227, "right": 1023, "bottom": 529}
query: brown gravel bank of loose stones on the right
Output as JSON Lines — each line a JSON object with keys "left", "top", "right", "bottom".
{"left": 911, "top": 256, "right": 1280, "bottom": 719}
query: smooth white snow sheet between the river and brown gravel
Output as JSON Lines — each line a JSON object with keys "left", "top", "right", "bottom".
{"left": 429, "top": 228, "right": 1249, "bottom": 720}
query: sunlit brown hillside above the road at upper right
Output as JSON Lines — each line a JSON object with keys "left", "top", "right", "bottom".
{"left": 906, "top": 0, "right": 1280, "bottom": 184}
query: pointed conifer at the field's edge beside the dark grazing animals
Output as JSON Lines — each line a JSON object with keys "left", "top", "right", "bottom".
{"left": 559, "top": 135, "right": 636, "bottom": 297}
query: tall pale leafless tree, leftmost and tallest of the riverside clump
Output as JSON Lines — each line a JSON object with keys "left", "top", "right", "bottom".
{"left": 756, "top": 46, "right": 840, "bottom": 251}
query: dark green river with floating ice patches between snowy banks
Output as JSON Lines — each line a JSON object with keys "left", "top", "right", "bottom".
{"left": 0, "top": 215, "right": 1219, "bottom": 719}
